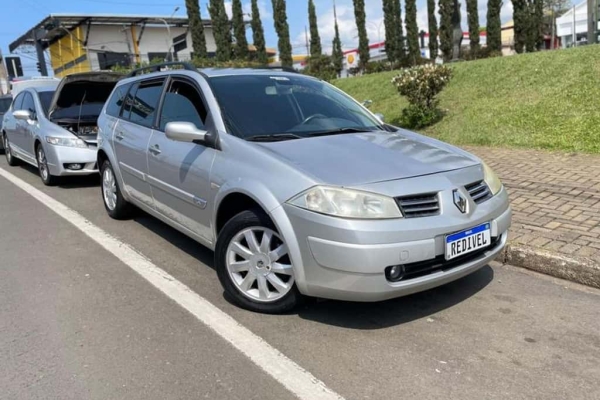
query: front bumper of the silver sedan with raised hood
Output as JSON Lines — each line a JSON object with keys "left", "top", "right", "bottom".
{"left": 44, "top": 143, "right": 98, "bottom": 176}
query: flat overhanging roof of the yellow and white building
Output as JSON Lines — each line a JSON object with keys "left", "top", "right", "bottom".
{"left": 8, "top": 13, "right": 211, "bottom": 52}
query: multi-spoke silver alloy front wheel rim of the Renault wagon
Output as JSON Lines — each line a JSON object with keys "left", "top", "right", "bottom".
{"left": 226, "top": 227, "right": 294, "bottom": 302}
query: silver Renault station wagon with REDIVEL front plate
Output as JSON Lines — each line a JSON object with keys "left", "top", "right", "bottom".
{"left": 98, "top": 64, "right": 511, "bottom": 313}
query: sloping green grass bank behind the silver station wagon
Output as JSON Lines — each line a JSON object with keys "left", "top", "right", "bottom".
{"left": 334, "top": 45, "right": 600, "bottom": 153}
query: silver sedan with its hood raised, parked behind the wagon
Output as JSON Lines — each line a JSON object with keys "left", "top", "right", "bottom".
{"left": 3, "top": 72, "right": 122, "bottom": 185}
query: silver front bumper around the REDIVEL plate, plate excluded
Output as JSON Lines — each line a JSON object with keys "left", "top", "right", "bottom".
{"left": 279, "top": 188, "right": 511, "bottom": 301}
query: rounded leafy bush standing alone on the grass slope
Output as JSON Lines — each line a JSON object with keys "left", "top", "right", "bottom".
{"left": 392, "top": 64, "right": 452, "bottom": 129}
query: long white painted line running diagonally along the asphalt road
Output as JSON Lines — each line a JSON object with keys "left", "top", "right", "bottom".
{"left": 0, "top": 168, "right": 344, "bottom": 400}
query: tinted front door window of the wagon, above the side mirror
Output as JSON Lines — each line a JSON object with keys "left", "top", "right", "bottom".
{"left": 160, "top": 81, "right": 206, "bottom": 131}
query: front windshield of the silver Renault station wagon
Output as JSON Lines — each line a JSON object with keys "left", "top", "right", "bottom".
{"left": 211, "top": 75, "right": 381, "bottom": 140}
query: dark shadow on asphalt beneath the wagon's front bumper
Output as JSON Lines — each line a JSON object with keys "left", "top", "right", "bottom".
{"left": 297, "top": 265, "right": 494, "bottom": 330}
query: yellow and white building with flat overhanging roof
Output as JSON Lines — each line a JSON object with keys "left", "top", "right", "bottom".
{"left": 9, "top": 14, "right": 216, "bottom": 77}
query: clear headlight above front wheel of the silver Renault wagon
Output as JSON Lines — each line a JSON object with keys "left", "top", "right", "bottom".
{"left": 288, "top": 186, "right": 402, "bottom": 219}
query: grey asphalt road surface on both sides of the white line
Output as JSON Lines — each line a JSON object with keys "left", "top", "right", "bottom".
{"left": 0, "top": 157, "right": 600, "bottom": 400}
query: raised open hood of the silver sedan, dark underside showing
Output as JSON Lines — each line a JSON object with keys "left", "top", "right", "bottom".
{"left": 48, "top": 72, "right": 123, "bottom": 119}
